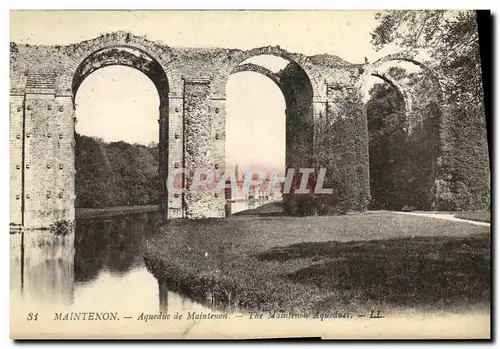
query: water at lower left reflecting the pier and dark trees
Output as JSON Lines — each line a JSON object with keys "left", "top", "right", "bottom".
{"left": 11, "top": 212, "right": 227, "bottom": 316}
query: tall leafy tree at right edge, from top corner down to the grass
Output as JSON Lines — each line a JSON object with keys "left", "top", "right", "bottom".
{"left": 372, "top": 10, "right": 490, "bottom": 209}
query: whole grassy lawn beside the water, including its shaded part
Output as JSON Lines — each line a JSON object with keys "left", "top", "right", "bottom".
{"left": 145, "top": 207, "right": 490, "bottom": 312}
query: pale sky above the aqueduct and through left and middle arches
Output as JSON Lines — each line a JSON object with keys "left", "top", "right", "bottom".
{"left": 10, "top": 11, "right": 402, "bottom": 173}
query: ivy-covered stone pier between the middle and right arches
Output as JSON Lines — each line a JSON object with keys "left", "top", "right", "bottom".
{"left": 315, "top": 85, "right": 369, "bottom": 214}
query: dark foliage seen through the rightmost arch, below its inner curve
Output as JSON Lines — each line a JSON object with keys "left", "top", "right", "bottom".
{"left": 367, "top": 84, "right": 439, "bottom": 210}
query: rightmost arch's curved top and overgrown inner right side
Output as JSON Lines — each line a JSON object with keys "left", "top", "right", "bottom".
{"left": 365, "top": 54, "right": 443, "bottom": 210}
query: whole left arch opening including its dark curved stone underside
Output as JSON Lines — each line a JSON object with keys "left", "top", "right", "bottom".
{"left": 72, "top": 47, "right": 168, "bottom": 213}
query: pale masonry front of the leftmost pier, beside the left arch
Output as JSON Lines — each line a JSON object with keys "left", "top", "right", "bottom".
{"left": 24, "top": 94, "right": 75, "bottom": 227}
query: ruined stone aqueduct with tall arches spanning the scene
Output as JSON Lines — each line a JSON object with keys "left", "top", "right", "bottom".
{"left": 10, "top": 32, "right": 440, "bottom": 228}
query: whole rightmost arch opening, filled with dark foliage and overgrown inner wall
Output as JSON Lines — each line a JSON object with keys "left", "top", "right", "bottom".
{"left": 365, "top": 59, "right": 441, "bottom": 210}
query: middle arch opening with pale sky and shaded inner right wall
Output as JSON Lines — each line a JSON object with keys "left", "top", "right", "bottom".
{"left": 226, "top": 54, "right": 314, "bottom": 214}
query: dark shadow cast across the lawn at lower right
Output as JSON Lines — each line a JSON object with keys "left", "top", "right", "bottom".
{"left": 255, "top": 234, "right": 491, "bottom": 310}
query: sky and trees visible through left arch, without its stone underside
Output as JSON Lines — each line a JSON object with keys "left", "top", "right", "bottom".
{"left": 75, "top": 66, "right": 160, "bottom": 209}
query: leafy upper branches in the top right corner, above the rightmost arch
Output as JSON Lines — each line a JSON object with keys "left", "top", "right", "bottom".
{"left": 372, "top": 10, "right": 484, "bottom": 114}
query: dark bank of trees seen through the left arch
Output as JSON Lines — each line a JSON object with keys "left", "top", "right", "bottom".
{"left": 75, "top": 134, "right": 159, "bottom": 207}
